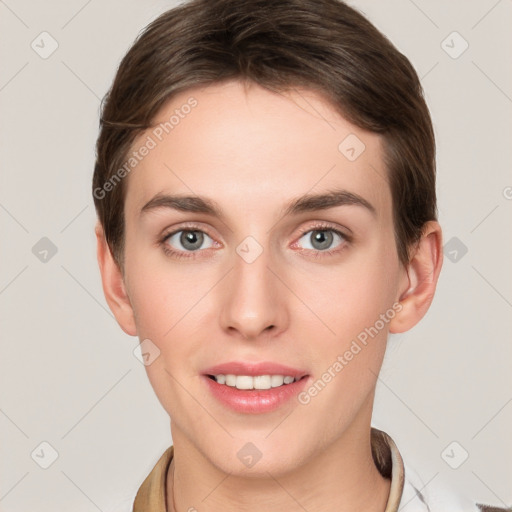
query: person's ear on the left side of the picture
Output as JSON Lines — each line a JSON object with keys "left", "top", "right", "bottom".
{"left": 95, "top": 221, "right": 137, "bottom": 336}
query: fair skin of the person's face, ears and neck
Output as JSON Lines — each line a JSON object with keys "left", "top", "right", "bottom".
{"left": 96, "top": 81, "right": 442, "bottom": 512}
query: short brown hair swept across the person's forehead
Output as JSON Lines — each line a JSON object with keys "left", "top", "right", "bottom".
{"left": 93, "top": 0, "right": 437, "bottom": 270}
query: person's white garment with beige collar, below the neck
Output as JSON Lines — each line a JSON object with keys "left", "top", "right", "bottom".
{"left": 109, "top": 427, "right": 512, "bottom": 512}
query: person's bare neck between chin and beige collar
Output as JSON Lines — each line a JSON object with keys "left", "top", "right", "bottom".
{"left": 167, "top": 416, "right": 391, "bottom": 512}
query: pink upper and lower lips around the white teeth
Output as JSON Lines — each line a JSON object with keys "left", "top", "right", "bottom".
{"left": 203, "top": 362, "right": 309, "bottom": 414}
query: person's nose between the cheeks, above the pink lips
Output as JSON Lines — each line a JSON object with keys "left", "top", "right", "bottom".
{"left": 220, "top": 243, "right": 289, "bottom": 340}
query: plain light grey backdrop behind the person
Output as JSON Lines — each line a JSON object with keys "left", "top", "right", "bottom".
{"left": 0, "top": 0, "right": 512, "bottom": 512}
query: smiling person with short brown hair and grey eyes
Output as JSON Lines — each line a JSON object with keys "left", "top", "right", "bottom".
{"left": 93, "top": 0, "right": 508, "bottom": 512}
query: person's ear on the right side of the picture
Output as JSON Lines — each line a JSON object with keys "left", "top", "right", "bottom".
{"left": 389, "top": 221, "right": 443, "bottom": 333}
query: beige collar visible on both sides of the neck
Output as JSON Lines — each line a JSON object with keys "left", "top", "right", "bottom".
{"left": 133, "top": 427, "right": 404, "bottom": 512}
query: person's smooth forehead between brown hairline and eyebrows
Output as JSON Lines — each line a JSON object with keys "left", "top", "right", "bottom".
{"left": 125, "top": 81, "right": 390, "bottom": 221}
